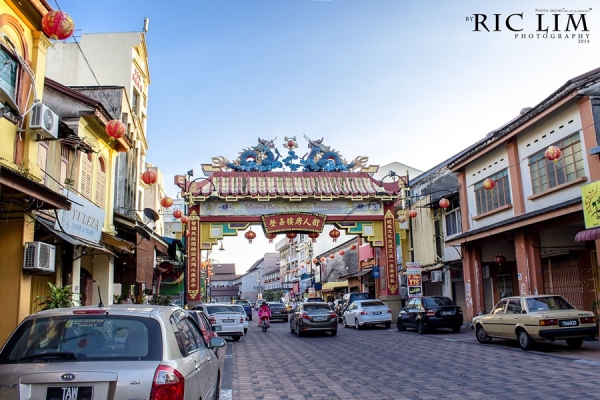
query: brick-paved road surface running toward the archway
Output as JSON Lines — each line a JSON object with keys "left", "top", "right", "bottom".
{"left": 221, "top": 316, "right": 600, "bottom": 400}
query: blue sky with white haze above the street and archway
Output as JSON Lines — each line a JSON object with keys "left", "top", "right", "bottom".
{"left": 50, "top": 0, "right": 600, "bottom": 272}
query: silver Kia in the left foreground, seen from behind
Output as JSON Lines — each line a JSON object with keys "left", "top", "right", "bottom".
{"left": 0, "top": 304, "right": 225, "bottom": 399}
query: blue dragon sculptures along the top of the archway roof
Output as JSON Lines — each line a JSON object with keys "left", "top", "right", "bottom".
{"left": 212, "top": 135, "right": 368, "bottom": 172}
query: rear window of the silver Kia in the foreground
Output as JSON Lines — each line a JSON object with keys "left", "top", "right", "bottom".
{"left": 0, "top": 315, "right": 162, "bottom": 364}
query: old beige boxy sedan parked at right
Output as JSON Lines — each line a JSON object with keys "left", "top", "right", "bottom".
{"left": 473, "top": 295, "right": 598, "bottom": 350}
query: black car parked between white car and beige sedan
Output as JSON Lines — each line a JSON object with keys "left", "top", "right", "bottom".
{"left": 396, "top": 296, "right": 463, "bottom": 334}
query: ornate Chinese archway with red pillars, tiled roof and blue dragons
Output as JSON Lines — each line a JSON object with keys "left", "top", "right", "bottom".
{"left": 175, "top": 136, "right": 403, "bottom": 302}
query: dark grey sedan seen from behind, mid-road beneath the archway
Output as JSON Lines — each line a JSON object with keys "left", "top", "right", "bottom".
{"left": 290, "top": 302, "right": 338, "bottom": 336}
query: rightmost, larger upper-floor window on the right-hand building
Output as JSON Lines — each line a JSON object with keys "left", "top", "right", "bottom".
{"left": 529, "top": 133, "right": 585, "bottom": 194}
